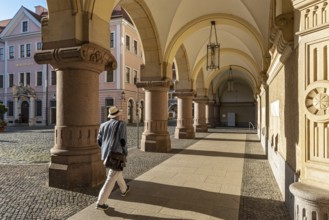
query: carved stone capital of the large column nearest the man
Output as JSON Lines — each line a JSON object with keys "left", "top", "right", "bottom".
{"left": 34, "top": 43, "right": 117, "bottom": 72}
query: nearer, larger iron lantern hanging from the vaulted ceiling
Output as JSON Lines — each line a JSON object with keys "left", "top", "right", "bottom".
{"left": 207, "top": 21, "right": 220, "bottom": 70}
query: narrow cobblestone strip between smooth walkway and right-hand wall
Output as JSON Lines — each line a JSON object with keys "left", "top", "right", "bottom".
{"left": 239, "top": 135, "right": 290, "bottom": 220}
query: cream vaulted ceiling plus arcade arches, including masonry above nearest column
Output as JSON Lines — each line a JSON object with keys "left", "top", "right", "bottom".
{"left": 43, "top": 0, "right": 278, "bottom": 96}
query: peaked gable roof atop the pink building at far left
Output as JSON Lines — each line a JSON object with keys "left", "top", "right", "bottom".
{"left": 0, "top": 6, "right": 43, "bottom": 38}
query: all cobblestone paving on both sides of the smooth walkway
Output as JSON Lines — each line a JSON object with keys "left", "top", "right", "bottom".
{"left": 0, "top": 125, "right": 289, "bottom": 220}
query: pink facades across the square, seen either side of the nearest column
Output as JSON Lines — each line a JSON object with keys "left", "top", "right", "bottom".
{"left": 0, "top": 6, "right": 144, "bottom": 126}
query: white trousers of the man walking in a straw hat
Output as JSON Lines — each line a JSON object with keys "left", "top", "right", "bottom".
{"left": 97, "top": 169, "right": 127, "bottom": 205}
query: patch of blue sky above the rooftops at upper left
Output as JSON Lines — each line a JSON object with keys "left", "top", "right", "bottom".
{"left": 0, "top": 0, "right": 47, "bottom": 21}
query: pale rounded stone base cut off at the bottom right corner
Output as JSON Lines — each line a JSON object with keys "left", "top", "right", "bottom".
{"left": 289, "top": 182, "right": 329, "bottom": 220}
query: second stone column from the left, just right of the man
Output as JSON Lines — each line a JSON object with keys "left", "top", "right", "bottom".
{"left": 137, "top": 81, "right": 171, "bottom": 152}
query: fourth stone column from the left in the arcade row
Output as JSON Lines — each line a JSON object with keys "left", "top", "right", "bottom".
{"left": 193, "top": 97, "right": 208, "bottom": 132}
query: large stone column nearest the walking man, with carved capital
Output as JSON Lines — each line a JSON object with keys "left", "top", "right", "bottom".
{"left": 34, "top": 44, "right": 116, "bottom": 188}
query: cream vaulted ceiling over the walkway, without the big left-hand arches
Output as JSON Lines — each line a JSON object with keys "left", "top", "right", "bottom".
{"left": 117, "top": 0, "right": 273, "bottom": 97}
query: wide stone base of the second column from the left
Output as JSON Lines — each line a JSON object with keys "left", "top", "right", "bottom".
{"left": 141, "top": 133, "right": 171, "bottom": 153}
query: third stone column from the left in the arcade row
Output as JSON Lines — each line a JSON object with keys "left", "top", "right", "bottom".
{"left": 173, "top": 91, "right": 195, "bottom": 139}
